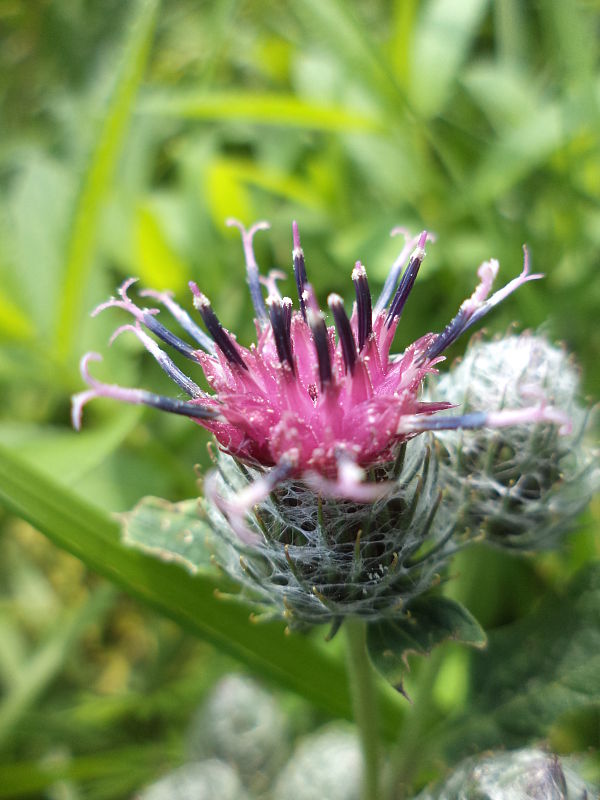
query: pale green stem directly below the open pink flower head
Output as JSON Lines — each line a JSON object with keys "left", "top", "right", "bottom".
{"left": 344, "top": 617, "right": 380, "bottom": 800}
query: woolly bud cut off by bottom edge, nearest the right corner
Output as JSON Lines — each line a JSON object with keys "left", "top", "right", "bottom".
{"left": 416, "top": 749, "right": 597, "bottom": 800}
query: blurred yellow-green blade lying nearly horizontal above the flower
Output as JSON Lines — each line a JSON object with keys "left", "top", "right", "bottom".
{"left": 141, "top": 91, "right": 380, "bottom": 131}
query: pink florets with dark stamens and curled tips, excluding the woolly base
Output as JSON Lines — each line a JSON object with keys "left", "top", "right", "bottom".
{"left": 73, "top": 220, "right": 547, "bottom": 502}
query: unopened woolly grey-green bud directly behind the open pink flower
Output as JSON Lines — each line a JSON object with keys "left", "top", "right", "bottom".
{"left": 432, "top": 333, "right": 600, "bottom": 550}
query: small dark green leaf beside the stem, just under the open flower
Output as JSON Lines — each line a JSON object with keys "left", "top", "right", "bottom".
{"left": 367, "top": 595, "right": 486, "bottom": 691}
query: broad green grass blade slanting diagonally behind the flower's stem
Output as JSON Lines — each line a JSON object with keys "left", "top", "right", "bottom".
{"left": 0, "top": 447, "right": 402, "bottom": 739}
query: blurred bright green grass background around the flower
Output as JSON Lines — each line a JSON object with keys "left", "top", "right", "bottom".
{"left": 0, "top": 0, "right": 600, "bottom": 798}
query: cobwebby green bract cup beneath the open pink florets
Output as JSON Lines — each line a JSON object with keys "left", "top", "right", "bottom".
{"left": 207, "top": 436, "right": 456, "bottom": 627}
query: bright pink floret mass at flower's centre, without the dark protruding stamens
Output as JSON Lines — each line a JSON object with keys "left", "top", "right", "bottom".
{"left": 197, "top": 312, "right": 449, "bottom": 477}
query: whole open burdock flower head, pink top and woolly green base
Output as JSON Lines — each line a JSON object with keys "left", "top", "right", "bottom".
{"left": 73, "top": 220, "right": 566, "bottom": 622}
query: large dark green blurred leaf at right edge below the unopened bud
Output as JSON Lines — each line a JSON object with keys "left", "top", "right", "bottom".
{"left": 443, "top": 563, "right": 600, "bottom": 756}
